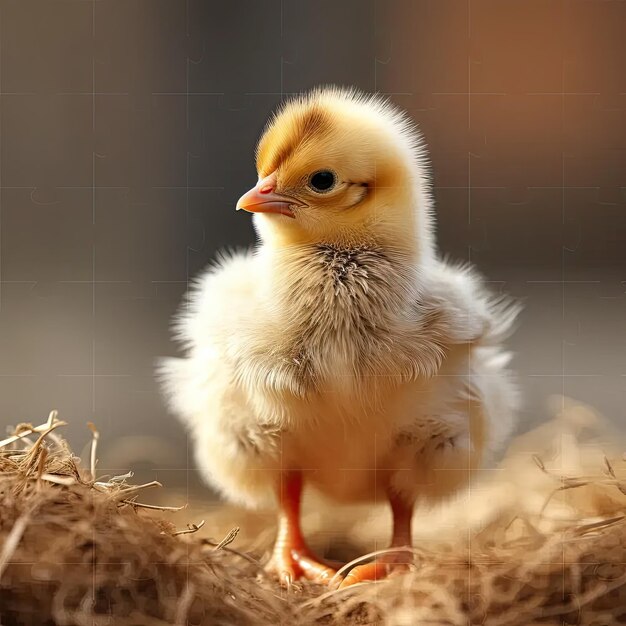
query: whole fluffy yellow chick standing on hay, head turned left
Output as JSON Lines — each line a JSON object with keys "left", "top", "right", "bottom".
{"left": 160, "top": 88, "right": 517, "bottom": 586}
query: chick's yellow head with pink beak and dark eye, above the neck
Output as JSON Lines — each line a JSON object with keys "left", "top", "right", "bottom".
{"left": 237, "top": 88, "right": 430, "bottom": 254}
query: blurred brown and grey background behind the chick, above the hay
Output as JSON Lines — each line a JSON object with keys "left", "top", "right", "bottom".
{"left": 0, "top": 0, "right": 626, "bottom": 494}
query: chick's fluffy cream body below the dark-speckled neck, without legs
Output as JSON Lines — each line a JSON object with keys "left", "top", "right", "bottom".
{"left": 161, "top": 245, "right": 515, "bottom": 506}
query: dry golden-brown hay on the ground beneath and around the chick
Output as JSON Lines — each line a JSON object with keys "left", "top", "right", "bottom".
{"left": 0, "top": 405, "right": 626, "bottom": 626}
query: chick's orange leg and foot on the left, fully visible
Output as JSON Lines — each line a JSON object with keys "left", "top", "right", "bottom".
{"left": 265, "top": 472, "right": 335, "bottom": 587}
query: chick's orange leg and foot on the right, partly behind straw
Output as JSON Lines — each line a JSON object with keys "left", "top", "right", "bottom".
{"left": 339, "top": 494, "right": 413, "bottom": 589}
